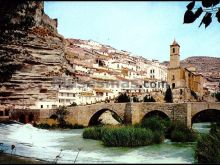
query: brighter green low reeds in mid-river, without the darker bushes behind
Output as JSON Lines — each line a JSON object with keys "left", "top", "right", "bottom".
{"left": 83, "top": 126, "right": 154, "bottom": 147}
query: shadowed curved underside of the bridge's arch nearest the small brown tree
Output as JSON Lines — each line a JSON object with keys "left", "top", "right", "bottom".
{"left": 88, "top": 108, "right": 123, "bottom": 126}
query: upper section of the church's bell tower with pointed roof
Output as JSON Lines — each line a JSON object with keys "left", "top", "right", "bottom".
{"left": 169, "top": 39, "right": 180, "bottom": 68}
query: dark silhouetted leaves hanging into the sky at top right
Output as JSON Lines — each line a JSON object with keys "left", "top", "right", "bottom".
{"left": 183, "top": 0, "right": 220, "bottom": 28}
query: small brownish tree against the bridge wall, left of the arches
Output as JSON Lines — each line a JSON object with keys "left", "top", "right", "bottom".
{"left": 54, "top": 106, "right": 69, "bottom": 128}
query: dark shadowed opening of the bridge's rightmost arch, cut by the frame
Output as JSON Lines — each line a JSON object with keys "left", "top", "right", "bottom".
{"left": 191, "top": 109, "right": 220, "bottom": 124}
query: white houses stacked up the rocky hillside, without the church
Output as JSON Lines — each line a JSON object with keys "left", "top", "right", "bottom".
{"left": 32, "top": 39, "right": 167, "bottom": 109}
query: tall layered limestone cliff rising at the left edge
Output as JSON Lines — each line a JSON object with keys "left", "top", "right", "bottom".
{"left": 0, "top": 1, "right": 69, "bottom": 106}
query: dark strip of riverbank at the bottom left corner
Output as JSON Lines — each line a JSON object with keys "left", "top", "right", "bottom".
{"left": 0, "top": 153, "right": 50, "bottom": 164}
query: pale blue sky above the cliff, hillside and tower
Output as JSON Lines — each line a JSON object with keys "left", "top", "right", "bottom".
{"left": 44, "top": 1, "right": 220, "bottom": 62}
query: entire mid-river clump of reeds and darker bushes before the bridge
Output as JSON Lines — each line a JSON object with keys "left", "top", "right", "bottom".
{"left": 83, "top": 116, "right": 197, "bottom": 147}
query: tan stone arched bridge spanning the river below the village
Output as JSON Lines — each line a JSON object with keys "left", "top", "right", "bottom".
{"left": 9, "top": 102, "right": 220, "bottom": 127}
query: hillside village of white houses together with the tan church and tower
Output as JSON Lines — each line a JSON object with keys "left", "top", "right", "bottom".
{"left": 31, "top": 39, "right": 220, "bottom": 109}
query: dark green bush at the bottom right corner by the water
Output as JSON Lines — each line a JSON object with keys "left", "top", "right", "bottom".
{"left": 195, "top": 122, "right": 220, "bottom": 164}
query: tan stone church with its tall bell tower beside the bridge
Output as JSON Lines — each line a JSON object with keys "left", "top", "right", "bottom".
{"left": 167, "top": 40, "right": 204, "bottom": 102}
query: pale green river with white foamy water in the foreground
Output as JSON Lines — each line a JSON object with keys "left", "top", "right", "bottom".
{"left": 0, "top": 123, "right": 210, "bottom": 163}
